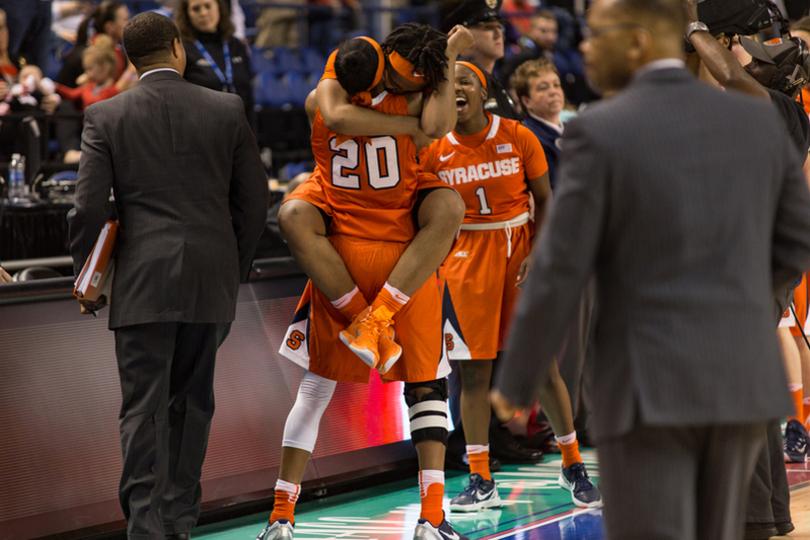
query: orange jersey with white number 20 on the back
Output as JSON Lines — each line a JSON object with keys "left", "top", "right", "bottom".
{"left": 312, "top": 92, "right": 444, "bottom": 242}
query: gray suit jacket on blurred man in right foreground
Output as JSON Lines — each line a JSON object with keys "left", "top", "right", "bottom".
{"left": 496, "top": 65, "right": 810, "bottom": 438}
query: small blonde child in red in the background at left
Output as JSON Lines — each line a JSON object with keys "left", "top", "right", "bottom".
{"left": 56, "top": 35, "right": 138, "bottom": 111}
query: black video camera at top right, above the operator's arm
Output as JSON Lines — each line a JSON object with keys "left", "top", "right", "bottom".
{"left": 697, "top": 0, "right": 788, "bottom": 36}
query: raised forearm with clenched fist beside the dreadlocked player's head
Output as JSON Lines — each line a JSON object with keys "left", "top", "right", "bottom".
{"left": 422, "top": 26, "right": 475, "bottom": 139}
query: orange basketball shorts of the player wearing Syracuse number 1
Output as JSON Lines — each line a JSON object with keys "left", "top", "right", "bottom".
{"left": 439, "top": 222, "right": 534, "bottom": 360}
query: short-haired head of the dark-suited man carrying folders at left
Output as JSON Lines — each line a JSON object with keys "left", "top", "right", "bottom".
{"left": 124, "top": 11, "right": 180, "bottom": 68}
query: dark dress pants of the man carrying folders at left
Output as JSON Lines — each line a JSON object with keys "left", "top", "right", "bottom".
{"left": 115, "top": 322, "right": 223, "bottom": 540}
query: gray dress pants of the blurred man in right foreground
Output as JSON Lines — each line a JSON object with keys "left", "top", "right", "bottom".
{"left": 597, "top": 422, "right": 766, "bottom": 540}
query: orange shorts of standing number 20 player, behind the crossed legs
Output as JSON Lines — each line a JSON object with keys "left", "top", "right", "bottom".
{"left": 279, "top": 235, "right": 450, "bottom": 382}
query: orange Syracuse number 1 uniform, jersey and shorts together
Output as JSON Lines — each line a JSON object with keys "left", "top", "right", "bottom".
{"left": 421, "top": 113, "right": 548, "bottom": 360}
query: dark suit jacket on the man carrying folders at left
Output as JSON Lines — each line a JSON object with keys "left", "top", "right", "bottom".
{"left": 68, "top": 71, "right": 268, "bottom": 328}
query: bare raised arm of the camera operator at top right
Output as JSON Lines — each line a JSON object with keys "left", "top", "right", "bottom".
{"left": 684, "top": 0, "right": 771, "bottom": 100}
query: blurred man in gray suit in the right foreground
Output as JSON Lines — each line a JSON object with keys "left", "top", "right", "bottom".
{"left": 493, "top": 0, "right": 810, "bottom": 540}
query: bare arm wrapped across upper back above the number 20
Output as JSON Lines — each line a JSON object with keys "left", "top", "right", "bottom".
{"left": 313, "top": 79, "right": 419, "bottom": 137}
